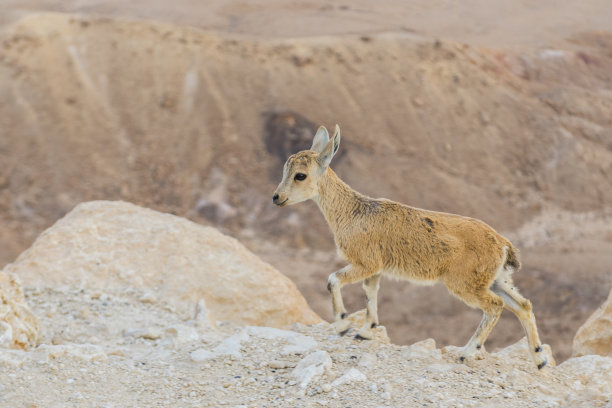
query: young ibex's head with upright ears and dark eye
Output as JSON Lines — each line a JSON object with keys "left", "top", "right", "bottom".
{"left": 272, "top": 125, "right": 340, "bottom": 207}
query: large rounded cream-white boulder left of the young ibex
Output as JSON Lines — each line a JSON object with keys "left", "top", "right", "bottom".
{"left": 4, "top": 201, "right": 321, "bottom": 327}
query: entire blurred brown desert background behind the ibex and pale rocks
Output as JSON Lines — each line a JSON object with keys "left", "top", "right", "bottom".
{"left": 0, "top": 0, "right": 612, "bottom": 361}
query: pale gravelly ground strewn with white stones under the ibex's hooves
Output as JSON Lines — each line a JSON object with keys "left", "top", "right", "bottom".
{"left": 0, "top": 288, "right": 612, "bottom": 408}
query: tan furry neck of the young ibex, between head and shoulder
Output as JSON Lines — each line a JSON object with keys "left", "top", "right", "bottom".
{"left": 314, "top": 167, "right": 368, "bottom": 235}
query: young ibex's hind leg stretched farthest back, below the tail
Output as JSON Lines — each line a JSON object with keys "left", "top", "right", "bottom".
{"left": 491, "top": 278, "right": 548, "bottom": 369}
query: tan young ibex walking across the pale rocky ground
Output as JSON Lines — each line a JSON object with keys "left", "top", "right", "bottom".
{"left": 273, "top": 125, "right": 547, "bottom": 368}
